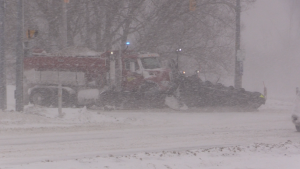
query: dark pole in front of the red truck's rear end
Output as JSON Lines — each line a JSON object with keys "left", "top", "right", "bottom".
{"left": 15, "top": 0, "right": 24, "bottom": 112}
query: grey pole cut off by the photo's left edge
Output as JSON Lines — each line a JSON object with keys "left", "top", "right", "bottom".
{"left": 0, "top": 0, "right": 7, "bottom": 110}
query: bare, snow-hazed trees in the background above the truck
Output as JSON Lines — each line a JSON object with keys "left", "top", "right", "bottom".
{"left": 2, "top": 0, "right": 254, "bottom": 83}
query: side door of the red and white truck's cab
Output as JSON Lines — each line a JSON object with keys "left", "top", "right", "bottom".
{"left": 122, "top": 59, "right": 143, "bottom": 92}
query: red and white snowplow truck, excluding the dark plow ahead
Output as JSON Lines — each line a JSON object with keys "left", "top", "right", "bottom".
{"left": 24, "top": 51, "right": 176, "bottom": 108}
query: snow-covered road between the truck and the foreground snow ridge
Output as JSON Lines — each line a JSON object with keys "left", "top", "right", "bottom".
{"left": 0, "top": 99, "right": 300, "bottom": 169}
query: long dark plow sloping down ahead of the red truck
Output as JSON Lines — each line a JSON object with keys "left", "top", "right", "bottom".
{"left": 177, "top": 71, "right": 266, "bottom": 110}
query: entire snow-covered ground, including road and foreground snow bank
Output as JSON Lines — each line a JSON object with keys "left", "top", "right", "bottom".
{"left": 0, "top": 86, "right": 300, "bottom": 169}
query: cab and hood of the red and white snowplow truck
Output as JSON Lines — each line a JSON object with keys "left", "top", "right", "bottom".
{"left": 104, "top": 51, "right": 172, "bottom": 93}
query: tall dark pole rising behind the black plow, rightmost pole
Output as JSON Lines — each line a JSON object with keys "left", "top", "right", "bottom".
{"left": 234, "top": 0, "right": 243, "bottom": 89}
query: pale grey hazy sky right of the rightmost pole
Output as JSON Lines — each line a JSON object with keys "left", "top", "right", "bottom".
{"left": 241, "top": 0, "right": 300, "bottom": 98}
